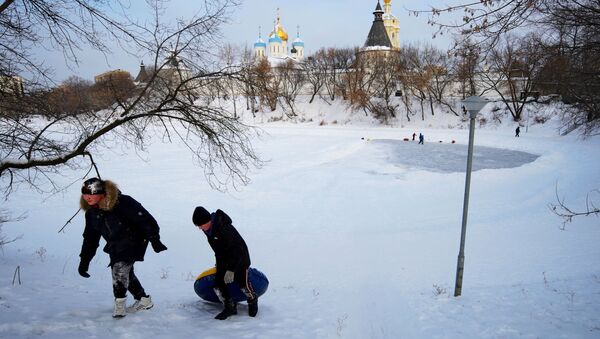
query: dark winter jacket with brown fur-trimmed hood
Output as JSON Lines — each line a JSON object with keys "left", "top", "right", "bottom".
{"left": 79, "top": 180, "right": 160, "bottom": 266}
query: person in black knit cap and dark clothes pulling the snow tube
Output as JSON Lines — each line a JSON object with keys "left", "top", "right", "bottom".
{"left": 192, "top": 206, "right": 258, "bottom": 320}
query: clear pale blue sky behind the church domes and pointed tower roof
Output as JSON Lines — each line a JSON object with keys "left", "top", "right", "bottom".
{"left": 43, "top": 0, "right": 450, "bottom": 81}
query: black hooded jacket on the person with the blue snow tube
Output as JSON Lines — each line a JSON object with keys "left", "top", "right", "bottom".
{"left": 205, "top": 210, "right": 250, "bottom": 272}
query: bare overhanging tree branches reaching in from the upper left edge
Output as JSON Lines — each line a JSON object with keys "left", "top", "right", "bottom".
{"left": 0, "top": 0, "right": 261, "bottom": 197}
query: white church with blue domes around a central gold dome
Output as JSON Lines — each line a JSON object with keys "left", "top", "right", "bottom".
{"left": 254, "top": 9, "right": 304, "bottom": 64}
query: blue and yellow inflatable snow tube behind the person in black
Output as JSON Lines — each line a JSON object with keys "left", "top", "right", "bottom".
{"left": 194, "top": 267, "right": 269, "bottom": 303}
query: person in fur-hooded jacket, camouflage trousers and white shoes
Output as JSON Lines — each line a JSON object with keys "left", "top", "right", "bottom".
{"left": 78, "top": 178, "right": 167, "bottom": 318}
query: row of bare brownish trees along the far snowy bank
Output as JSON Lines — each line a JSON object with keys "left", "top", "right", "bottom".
{"left": 213, "top": 25, "right": 600, "bottom": 130}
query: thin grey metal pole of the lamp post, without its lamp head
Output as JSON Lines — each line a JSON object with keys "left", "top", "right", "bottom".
{"left": 454, "top": 112, "right": 477, "bottom": 297}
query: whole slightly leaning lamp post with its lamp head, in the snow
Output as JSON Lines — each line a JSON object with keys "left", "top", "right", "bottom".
{"left": 454, "top": 96, "right": 487, "bottom": 297}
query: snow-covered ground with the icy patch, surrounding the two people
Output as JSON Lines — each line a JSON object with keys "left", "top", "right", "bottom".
{"left": 0, "top": 101, "right": 600, "bottom": 338}
